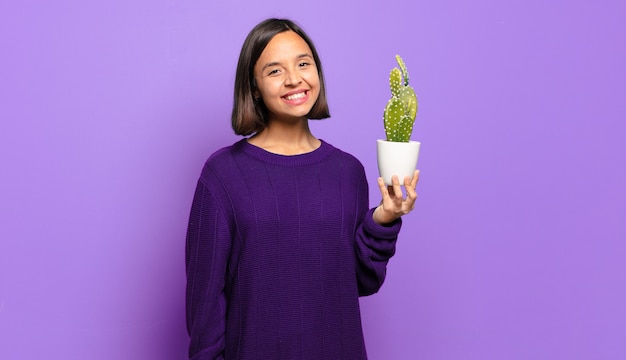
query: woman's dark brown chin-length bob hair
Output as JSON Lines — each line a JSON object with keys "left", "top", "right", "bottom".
{"left": 231, "top": 19, "right": 330, "bottom": 136}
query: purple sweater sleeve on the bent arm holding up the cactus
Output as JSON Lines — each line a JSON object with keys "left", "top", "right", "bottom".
{"left": 356, "top": 176, "right": 402, "bottom": 296}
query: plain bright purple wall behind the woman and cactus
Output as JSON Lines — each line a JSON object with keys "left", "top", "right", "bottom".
{"left": 0, "top": 0, "right": 626, "bottom": 360}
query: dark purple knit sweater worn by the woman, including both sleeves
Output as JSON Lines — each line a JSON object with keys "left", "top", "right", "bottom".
{"left": 186, "top": 139, "right": 401, "bottom": 360}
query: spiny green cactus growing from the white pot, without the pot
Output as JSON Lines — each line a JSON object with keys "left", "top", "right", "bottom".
{"left": 384, "top": 55, "right": 417, "bottom": 142}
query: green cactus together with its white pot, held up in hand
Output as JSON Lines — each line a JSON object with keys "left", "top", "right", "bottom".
{"left": 377, "top": 55, "right": 420, "bottom": 185}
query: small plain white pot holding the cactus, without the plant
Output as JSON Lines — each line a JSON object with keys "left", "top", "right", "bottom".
{"left": 376, "top": 140, "right": 420, "bottom": 186}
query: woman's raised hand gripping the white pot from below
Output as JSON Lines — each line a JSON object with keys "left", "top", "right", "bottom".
{"left": 373, "top": 170, "right": 419, "bottom": 225}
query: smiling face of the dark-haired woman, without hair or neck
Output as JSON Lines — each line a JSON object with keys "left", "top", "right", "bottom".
{"left": 254, "top": 31, "right": 320, "bottom": 121}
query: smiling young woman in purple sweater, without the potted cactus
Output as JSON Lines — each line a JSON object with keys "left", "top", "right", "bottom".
{"left": 186, "top": 19, "right": 419, "bottom": 360}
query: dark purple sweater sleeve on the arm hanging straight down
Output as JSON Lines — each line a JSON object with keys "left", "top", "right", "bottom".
{"left": 185, "top": 181, "right": 231, "bottom": 360}
